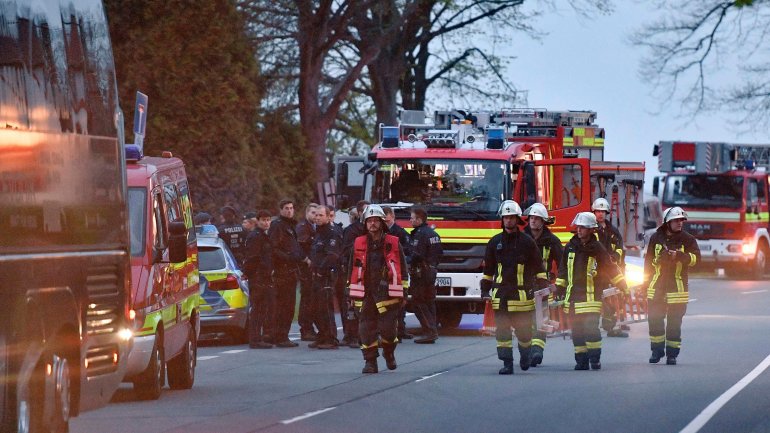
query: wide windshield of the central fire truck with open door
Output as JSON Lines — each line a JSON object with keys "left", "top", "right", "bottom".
{"left": 372, "top": 159, "right": 511, "bottom": 220}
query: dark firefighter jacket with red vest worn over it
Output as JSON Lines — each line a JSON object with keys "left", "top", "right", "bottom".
{"left": 350, "top": 234, "right": 408, "bottom": 312}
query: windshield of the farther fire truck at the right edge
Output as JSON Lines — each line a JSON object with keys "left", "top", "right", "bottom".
{"left": 663, "top": 174, "right": 743, "bottom": 209}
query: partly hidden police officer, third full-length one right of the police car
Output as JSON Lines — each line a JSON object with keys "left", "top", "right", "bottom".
{"left": 296, "top": 203, "right": 318, "bottom": 341}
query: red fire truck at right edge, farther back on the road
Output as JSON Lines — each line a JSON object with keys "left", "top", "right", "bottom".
{"left": 653, "top": 141, "right": 770, "bottom": 279}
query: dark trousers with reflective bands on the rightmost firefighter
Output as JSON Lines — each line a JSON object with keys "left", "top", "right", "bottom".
{"left": 647, "top": 299, "right": 687, "bottom": 358}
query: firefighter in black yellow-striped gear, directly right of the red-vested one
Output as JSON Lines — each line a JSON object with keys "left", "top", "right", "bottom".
{"left": 481, "top": 200, "right": 548, "bottom": 374}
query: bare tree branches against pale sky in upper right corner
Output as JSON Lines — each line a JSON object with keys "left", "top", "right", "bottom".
{"left": 631, "top": 0, "right": 770, "bottom": 130}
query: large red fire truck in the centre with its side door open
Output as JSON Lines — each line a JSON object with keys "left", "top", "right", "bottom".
{"left": 338, "top": 109, "right": 644, "bottom": 328}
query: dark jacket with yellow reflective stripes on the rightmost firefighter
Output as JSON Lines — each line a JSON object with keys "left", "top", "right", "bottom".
{"left": 644, "top": 224, "right": 700, "bottom": 304}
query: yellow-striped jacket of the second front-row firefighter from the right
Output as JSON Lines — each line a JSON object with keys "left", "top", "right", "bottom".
{"left": 556, "top": 235, "right": 627, "bottom": 314}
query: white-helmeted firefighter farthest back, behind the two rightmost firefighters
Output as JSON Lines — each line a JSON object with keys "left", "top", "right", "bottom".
{"left": 591, "top": 198, "right": 629, "bottom": 338}
